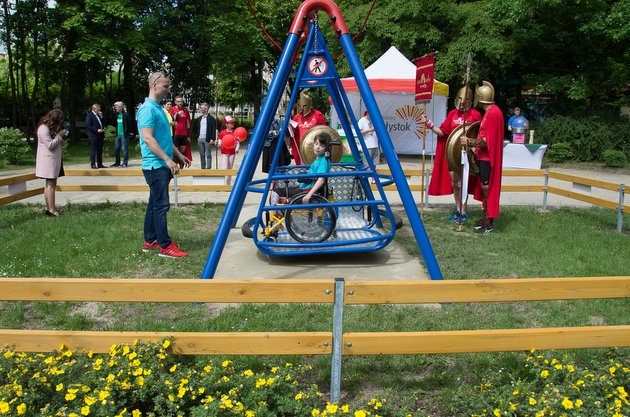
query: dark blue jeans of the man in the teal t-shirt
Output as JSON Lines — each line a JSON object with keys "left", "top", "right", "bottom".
{"left": 142, "top": 168, "right": 171, "bottom": 248}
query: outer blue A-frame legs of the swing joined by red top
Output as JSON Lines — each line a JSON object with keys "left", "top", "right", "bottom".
{"left": 201, "top": 0, "right": 442, "bottom": 280}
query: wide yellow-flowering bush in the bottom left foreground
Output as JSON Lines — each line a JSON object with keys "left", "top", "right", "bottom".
{"left": 0, "top": 339, "right": 420, "bottom": 417}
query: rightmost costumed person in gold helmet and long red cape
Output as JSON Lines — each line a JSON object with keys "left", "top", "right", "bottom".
{"left": 461, "top": 81, "right": 505, "bottom": 234}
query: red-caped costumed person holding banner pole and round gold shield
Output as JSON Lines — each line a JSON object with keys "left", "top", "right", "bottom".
{"left": 420, "top": 87, "right": 481, "bottom": 223}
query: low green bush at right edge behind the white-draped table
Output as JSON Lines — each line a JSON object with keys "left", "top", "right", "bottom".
{"left": 536, "top": 116, "right": 630, "bottom": 161}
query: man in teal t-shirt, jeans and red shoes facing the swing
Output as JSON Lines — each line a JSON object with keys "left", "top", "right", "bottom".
{"left": 136, "top": 72, "right": 190, "bottom": 258}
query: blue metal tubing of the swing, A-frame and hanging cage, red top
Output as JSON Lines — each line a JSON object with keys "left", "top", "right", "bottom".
{"left": 201, "top": 0, "right": 442, "bottom": 280}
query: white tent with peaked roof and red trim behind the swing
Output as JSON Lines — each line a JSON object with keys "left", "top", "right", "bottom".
{"left": 331, "top": 46, "right": 448, "bottom": 155}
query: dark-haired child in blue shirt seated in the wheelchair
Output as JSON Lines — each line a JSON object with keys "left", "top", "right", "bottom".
{"left": 269, "top": 132, "right": 332, "bottom": 206}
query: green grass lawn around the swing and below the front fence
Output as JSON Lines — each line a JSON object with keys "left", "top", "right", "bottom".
{"left": 0, "top": 204, "right": 630, "bottom": 417}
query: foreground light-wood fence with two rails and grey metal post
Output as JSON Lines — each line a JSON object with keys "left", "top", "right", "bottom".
{"left": 0, "top": 276, "right": 630, "bottom": 402}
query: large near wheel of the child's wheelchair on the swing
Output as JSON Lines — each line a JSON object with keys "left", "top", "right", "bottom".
{"left": 286, "top": 193, "right": 337, "bottom": 243}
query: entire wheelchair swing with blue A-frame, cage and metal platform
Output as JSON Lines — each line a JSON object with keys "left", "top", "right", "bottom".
{"left": 201, "top": 0, "right": 442, "bottom": 279}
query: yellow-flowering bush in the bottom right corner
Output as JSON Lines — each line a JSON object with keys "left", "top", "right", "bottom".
{"left": 455, "top": 351, "right": 630, "bottom": 417}
